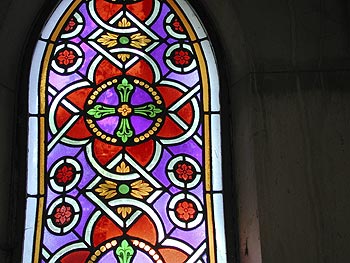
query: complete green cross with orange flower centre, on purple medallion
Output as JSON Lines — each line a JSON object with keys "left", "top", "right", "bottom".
{"left": 87, "top": 78, "right": 162, "bottom": 143}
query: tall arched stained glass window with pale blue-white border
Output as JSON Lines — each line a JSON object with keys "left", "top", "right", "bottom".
{"left": 23, "top": 0, "right": 226, "bottom": 263}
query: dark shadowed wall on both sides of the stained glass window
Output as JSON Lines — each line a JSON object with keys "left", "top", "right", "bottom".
{"left": 0, "top": 0, "right": 350, "bottom": 263}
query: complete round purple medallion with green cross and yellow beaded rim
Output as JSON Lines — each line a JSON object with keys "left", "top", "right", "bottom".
{"left": 85, "top": 76, "right": 166, "bottom": 146}
